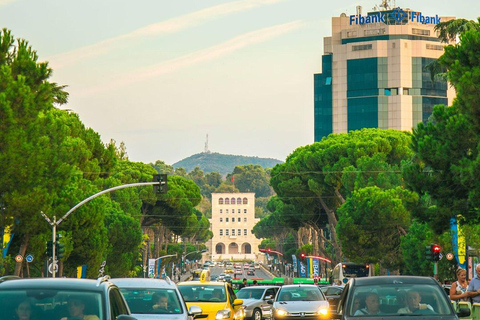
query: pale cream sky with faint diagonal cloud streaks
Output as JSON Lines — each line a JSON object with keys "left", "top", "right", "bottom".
{"left": 0, "top": 0, "right": 480, "bottom": 164}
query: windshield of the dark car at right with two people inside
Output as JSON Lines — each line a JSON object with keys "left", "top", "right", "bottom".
{"left": 347, "top": 283, "right": 452, "bottom": 317}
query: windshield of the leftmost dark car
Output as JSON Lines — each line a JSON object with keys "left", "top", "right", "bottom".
{"left": 0, "top": 289, "right": 104, "bottom": 320}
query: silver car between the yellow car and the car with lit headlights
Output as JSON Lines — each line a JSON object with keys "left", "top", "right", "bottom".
{"left": 237, "top": 286, "right": 280, "bottom": 320}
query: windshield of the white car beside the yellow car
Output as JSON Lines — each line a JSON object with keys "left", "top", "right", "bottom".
{"left": 120, "top": 288, "right": 183, "bottom": 314}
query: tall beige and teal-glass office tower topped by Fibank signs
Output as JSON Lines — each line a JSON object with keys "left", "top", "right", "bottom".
{"left": 314, "top": 7, "right": 455, "bottom": 141}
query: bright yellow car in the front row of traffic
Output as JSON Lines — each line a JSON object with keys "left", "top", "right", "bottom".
{"left": 177, "top": 279, "right": 245, "bottom": 320}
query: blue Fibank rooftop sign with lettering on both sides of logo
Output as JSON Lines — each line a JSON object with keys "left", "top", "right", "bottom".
{"left": 350, "top": 8, "right": 440, "bottom": 25}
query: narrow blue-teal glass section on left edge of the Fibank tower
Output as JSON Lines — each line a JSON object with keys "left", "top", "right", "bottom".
{"left": 313, "top": 55, "right": 333, "bottom": 141}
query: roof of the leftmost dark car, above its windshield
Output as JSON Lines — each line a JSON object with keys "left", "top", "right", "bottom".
{"left": 0, "top": 278, "right": 111, "bottom": 292}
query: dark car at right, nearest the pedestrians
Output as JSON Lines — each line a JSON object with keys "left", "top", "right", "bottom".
{"left": 331, "top": 276, "right": 470, "bottom": 320}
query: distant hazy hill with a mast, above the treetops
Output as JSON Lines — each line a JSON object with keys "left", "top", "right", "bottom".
{"left": 173, "top": 152, "right": 283, "bottom": 176}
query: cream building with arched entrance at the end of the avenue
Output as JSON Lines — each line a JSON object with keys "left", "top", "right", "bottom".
{"left": 206, "top": 193, "right": 263, "bottom": 261}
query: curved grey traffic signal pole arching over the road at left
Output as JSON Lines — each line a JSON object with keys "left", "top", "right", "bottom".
{"left": 40, "top": 175, "right": 167, "bottom": 278}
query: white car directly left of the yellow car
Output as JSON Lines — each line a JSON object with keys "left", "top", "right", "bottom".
{"left": 111, "top": 278, "right": 202, "bottom": 320}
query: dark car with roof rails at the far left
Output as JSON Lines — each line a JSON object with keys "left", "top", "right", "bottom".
{"left": 0, "top": 276, "right": 136, "bottom": 320}
